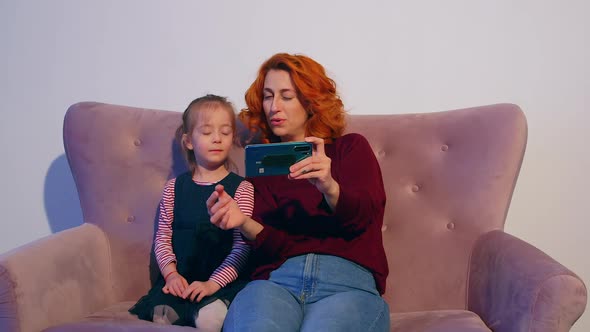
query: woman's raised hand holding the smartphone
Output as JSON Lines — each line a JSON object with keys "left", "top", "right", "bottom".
{"left": 289, "top": 137, "right": 340, "bottom": 211}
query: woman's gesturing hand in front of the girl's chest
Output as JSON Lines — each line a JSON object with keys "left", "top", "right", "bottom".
{"left": 207, "top": 184, "right": 247, "bottom": 229}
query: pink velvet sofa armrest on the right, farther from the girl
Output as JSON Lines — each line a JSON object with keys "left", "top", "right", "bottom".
{"left": 467, "top": 231, "right": 587, "bottom": 332}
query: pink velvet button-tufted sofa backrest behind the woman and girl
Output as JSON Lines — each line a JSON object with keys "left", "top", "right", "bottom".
{"left": 64, "top": 102, "right": 526, "bottom": 311}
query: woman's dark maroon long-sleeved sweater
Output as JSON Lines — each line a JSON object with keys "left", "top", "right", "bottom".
{"left": 249, "top": 134, "right": 389, "bottom": 294}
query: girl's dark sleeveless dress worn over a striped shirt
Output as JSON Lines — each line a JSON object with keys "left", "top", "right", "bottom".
{"left": 129, "top": 172, "right": 246, "bottom": 327}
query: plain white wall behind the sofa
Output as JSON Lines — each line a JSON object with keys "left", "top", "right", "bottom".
{"left": 0, "top": 0, "right": 590, "bottom": 331}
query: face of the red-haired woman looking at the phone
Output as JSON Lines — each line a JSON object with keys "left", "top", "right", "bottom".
{"left": 262, "top": 69, "right": 308, "bottom": 142}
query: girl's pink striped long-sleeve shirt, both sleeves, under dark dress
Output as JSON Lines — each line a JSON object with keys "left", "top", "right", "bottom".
{"left": 154, "top": 179, "right": 254, "bottom": 287}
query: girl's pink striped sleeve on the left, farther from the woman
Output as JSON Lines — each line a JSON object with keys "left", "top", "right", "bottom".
{"left": 154, "top": 179, "right": 176, "bottom": 271}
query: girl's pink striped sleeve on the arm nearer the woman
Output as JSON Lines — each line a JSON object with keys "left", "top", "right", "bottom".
{"left": 210, "top": 181, "right": 254, "bottom": 287}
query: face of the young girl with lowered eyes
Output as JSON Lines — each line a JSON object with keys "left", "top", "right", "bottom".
{"left": 183, "top": 105, "right": 234, "bottom": 170}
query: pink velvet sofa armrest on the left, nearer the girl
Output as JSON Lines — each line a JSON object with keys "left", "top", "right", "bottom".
{"left": 0, "top": 224, "right": 114, "bottom": 332}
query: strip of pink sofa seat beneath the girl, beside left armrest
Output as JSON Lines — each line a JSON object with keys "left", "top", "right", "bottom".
{"left": 43, "top": 301, "right": 196, "bottom": 332}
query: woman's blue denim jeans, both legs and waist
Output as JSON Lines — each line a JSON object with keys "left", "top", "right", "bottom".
{"left": 223, "top": 254, "right": 389, "bottom": 332}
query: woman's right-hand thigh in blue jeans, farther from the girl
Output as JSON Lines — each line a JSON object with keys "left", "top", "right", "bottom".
{"left": 301, "top": 290, "right": 389, "bottom": 332}
